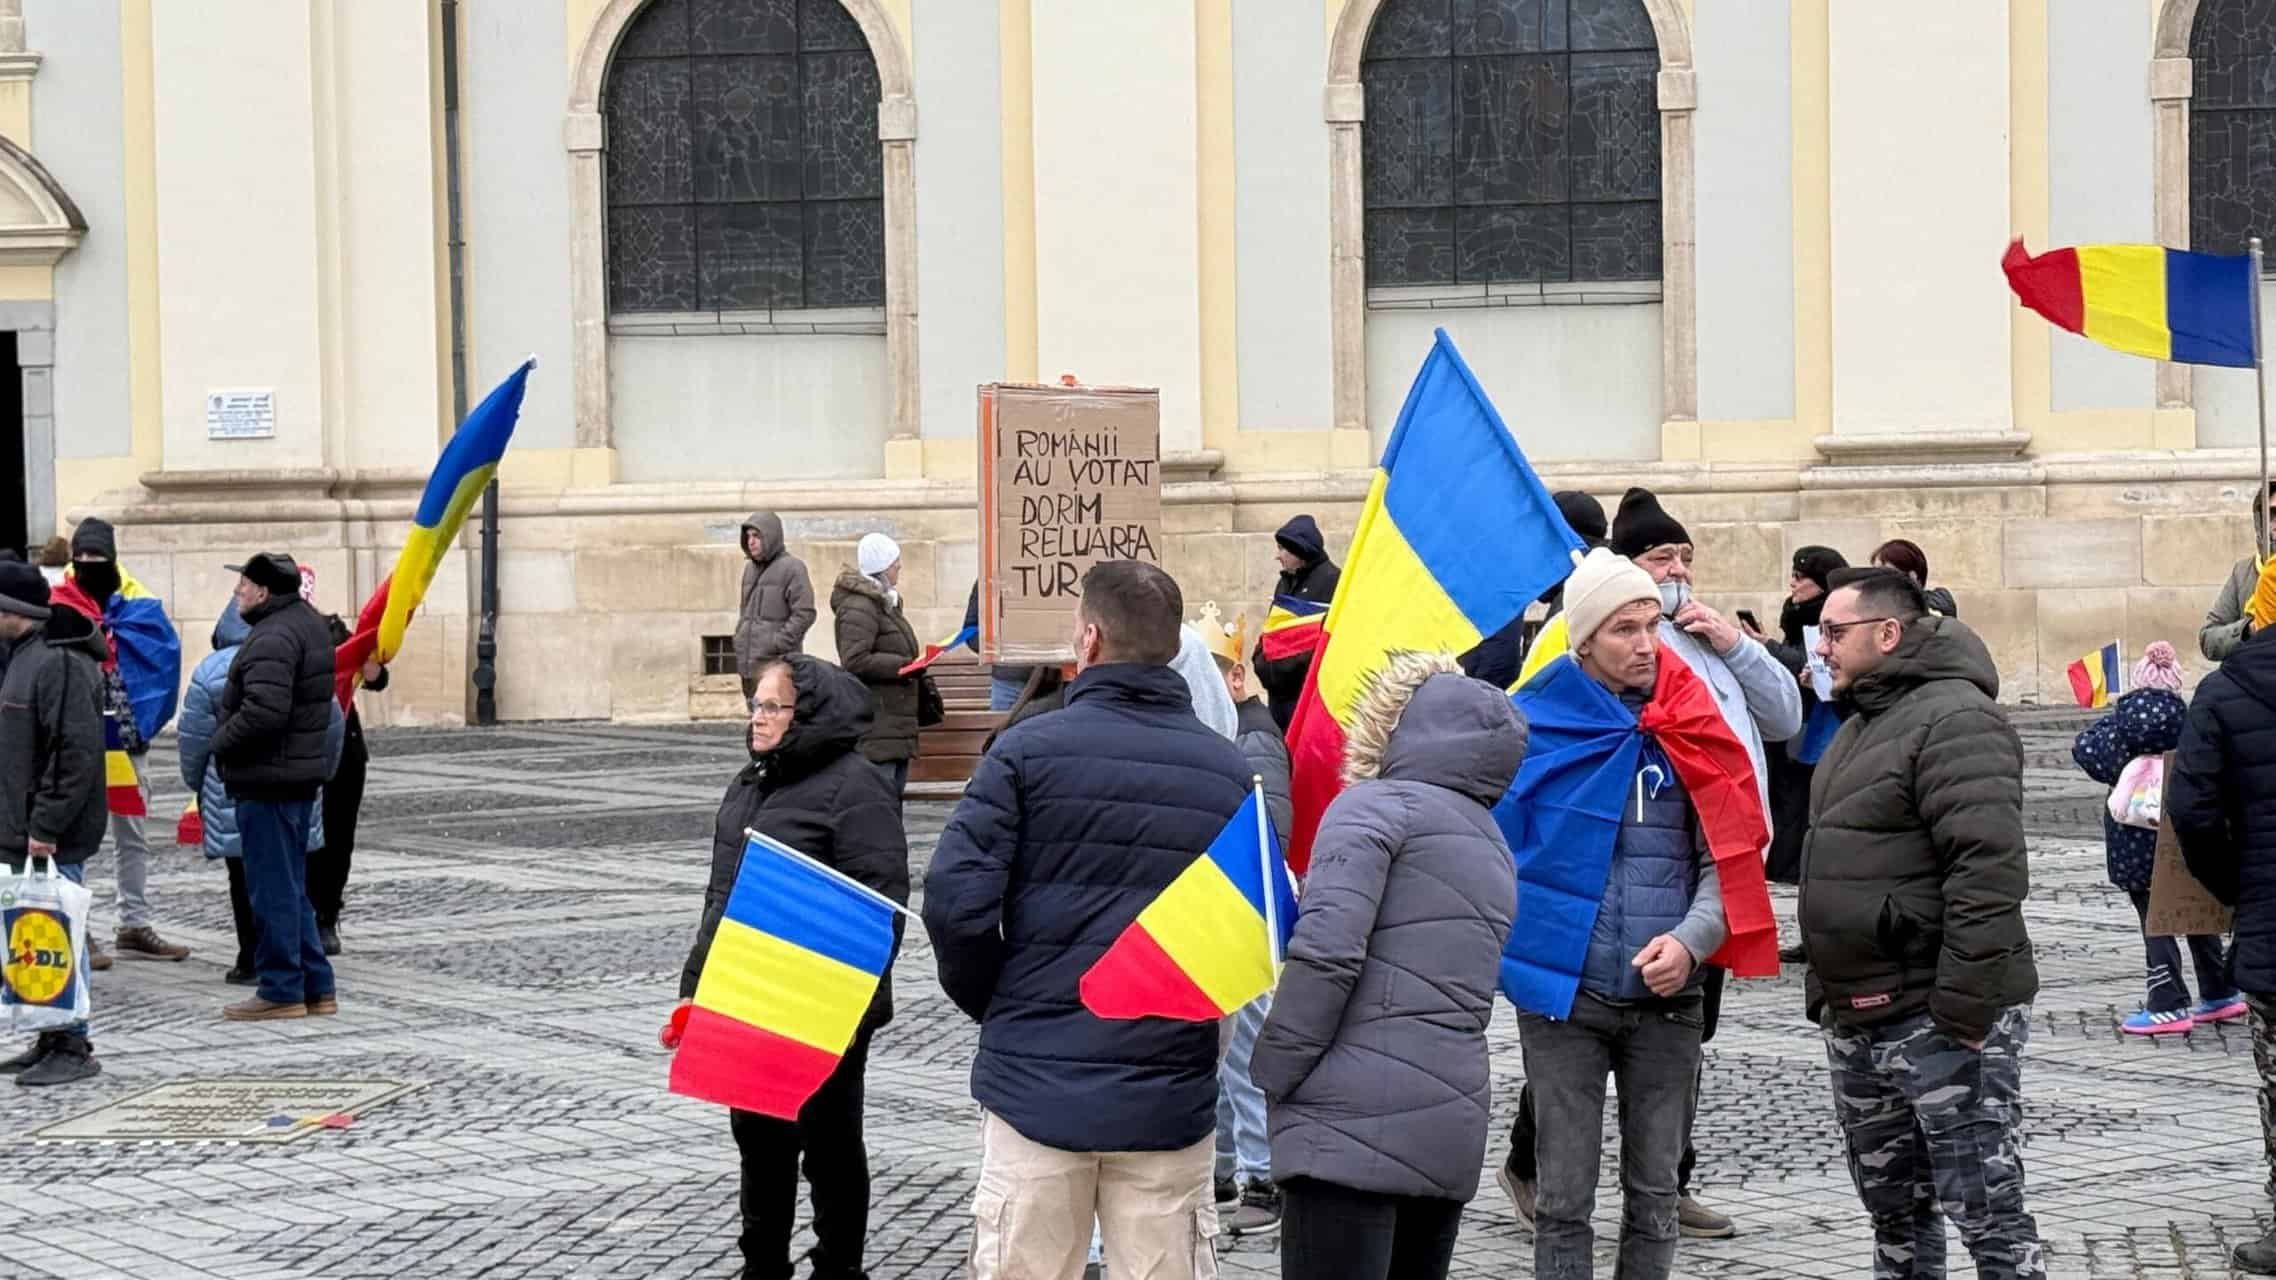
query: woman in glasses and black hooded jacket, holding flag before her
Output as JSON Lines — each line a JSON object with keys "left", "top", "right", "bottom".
{"left": 681, "top": 654, "right": 908, "bottom": 1280}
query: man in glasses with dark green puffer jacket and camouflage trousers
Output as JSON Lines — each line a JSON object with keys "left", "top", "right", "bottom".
{"left": 1800, "top": 569, "right": 2046, "bottom": 1278}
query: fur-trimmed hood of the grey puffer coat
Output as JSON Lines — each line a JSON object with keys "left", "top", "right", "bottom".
{"left": 1343, "top": 651, "right": 1525, "bottom": 806}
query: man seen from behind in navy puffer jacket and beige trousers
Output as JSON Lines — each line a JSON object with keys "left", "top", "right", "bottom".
{"left": 924, "top": 560, "right": 1250, "bottom": 1280}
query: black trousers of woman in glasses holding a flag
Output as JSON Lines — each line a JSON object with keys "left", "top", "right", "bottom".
{"left": 728, "top": 1032, "right": 869, "bottom": 1280}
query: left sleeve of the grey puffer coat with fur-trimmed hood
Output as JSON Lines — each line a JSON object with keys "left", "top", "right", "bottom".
{"left": 1250, "top": 788, "right": 1409, "bottom": 1102}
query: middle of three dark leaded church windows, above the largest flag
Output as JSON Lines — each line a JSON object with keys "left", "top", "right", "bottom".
{"left": 1359, "top": 0, "right": 1666, "bottom": 285}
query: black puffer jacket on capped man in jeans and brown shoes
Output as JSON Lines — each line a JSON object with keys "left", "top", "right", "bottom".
{"left": 212, "top": 594, "right": 335, "bottom": 799}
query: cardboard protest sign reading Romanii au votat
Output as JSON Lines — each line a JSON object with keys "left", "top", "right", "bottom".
{"left": 979, "top": 383, "right": 1161, "bottom": 665}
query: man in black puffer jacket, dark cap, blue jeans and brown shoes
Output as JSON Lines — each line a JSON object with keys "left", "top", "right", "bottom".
{"left": 212, "top": 551, "right": 339, "bottom": 1023}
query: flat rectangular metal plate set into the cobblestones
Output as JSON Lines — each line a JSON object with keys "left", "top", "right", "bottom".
{"left": 32, "top": 1080, "right": 419, "bottom": 1143}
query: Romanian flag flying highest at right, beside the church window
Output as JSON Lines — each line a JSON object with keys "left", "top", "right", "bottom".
{"left": 2001, "top": 239, "right": 2253, "bottom": 369}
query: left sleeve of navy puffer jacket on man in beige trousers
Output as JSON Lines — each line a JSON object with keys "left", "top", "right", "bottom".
{"left": 924, "top": 742, "right": 1020, "bottom": 1023}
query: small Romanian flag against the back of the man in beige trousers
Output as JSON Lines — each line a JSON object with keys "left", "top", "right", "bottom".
{"left": 1081, "top": 783, "right": 1295, "bottom": 1023}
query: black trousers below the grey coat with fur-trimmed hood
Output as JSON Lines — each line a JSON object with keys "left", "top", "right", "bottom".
{"left": 1281, "top": 1178, "right": 1461, "bottom": 1280}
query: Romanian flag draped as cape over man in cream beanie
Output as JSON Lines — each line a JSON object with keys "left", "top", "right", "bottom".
{"left": 1493, "top": 645, "right": 1778, "bottom": 1018}
